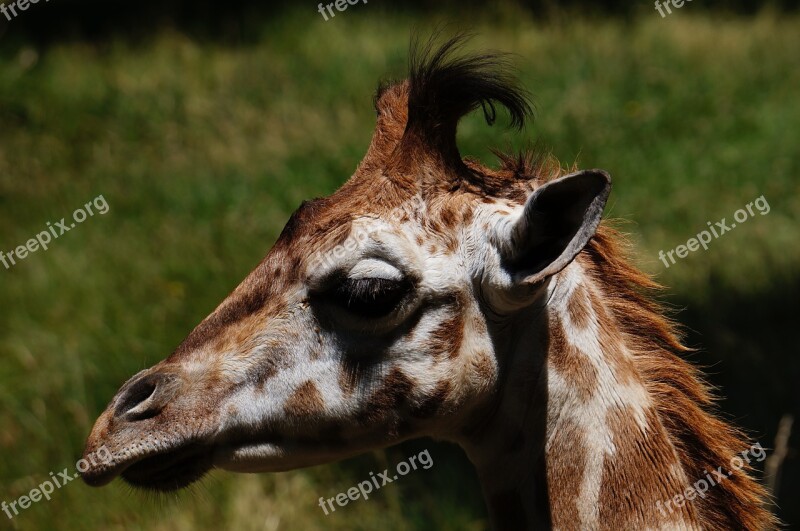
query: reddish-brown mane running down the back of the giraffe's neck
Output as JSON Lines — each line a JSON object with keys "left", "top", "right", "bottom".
{"left": 578, "top": 221, "right": 778, "bottom": 529}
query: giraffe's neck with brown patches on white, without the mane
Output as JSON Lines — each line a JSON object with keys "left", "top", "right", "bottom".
{"left": 465, "top": 262, "right": 700, "bottom": 530}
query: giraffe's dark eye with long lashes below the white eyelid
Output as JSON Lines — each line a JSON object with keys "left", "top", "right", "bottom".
{"left": 329, "top": 278, "right": 411, "bottom": 319}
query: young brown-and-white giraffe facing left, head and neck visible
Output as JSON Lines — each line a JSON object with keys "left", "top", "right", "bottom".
{"left": 82, "top": 36, "right": 776, "bottom": 530}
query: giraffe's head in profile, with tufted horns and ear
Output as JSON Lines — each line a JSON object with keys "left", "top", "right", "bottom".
{"left": 83, "top": 39, "right": 610, "bottom": 490}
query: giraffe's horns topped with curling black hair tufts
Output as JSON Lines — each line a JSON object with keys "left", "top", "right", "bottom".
{"left": 362, "top": 33, "right": 533, "bottom": 178}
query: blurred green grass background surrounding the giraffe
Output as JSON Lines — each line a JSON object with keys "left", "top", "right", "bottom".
{"left": 0, "top": 2, "right": 800, "bottom": 530}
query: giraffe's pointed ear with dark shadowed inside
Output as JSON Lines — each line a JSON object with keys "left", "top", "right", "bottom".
{"left": 501, "top": 170, "right": 611, "bottom": 286}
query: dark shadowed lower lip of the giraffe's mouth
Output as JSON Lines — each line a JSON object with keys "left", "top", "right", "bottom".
{"left": 120, "top": 444, "right": 213, "bottom": 492}
